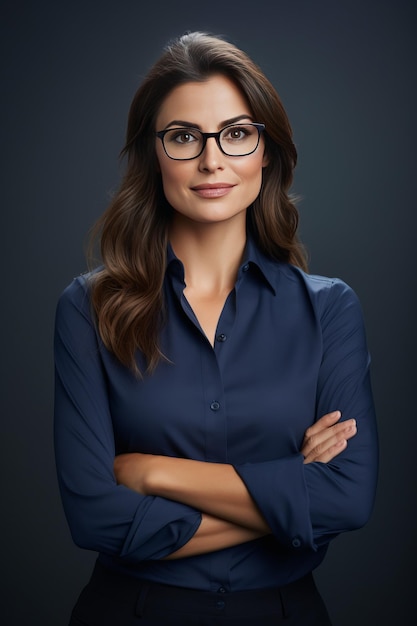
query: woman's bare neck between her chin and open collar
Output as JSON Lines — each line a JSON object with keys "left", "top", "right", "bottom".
{"left": 170, "top": 218, "right": 246, "bottom": 293}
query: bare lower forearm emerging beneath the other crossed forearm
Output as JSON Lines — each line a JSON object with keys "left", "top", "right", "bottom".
{"left": 166, "top": 514, "right": 265, "bottom": 560}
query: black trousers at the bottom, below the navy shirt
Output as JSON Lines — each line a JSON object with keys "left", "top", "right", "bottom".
{"left": 69, "top": 563, "right": 331, "bottom": 626}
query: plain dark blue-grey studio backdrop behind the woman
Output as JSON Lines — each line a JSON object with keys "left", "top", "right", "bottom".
{"left": 0, "top": 0, "right": 417, "bottom": 626}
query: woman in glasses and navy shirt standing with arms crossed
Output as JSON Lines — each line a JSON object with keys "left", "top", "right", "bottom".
{"left": 55, "top": 33, "right": 377, "bottom": 626}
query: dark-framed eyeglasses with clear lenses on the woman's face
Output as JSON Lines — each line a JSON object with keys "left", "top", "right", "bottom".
{"left": 156, "top": 123, "right": 265, "bottom": 161}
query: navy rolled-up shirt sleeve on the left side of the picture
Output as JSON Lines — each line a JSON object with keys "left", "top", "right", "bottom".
{"left": 54, "top": 278, "right": 201, "bottom": 562}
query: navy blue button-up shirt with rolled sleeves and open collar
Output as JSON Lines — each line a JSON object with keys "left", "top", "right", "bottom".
{"left": 55, "top": 236, "right": 377, "bottom": 591}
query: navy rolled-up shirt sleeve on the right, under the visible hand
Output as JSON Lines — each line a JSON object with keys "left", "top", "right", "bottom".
{"left": 235, "top": 279, "right": 378, "bottom": 550}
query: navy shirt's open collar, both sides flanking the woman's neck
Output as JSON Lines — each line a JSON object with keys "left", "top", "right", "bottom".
{"left": 167, "top": 234, "right": 279, "bottom": 295}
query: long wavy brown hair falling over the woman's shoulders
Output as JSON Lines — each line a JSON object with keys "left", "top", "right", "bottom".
{"left": 91, "top": 32, "right": 307, "bottom": 376}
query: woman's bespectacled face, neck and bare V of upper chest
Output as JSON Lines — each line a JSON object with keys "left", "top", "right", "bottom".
{"left": 156, "top": 74, "right": 268, "bottom": 345}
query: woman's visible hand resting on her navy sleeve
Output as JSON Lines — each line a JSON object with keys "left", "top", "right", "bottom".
{"left": 301, "top": 411, "right": 356, "bottom": 463}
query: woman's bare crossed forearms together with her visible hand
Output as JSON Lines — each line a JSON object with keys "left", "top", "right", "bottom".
{"left": 114, "top": 411, "right": 356, "bottom": 559}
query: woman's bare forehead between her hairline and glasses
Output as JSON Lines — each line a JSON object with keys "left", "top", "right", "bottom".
{"left": 157, "top": 75, "right": 252, "bottom": 128}
